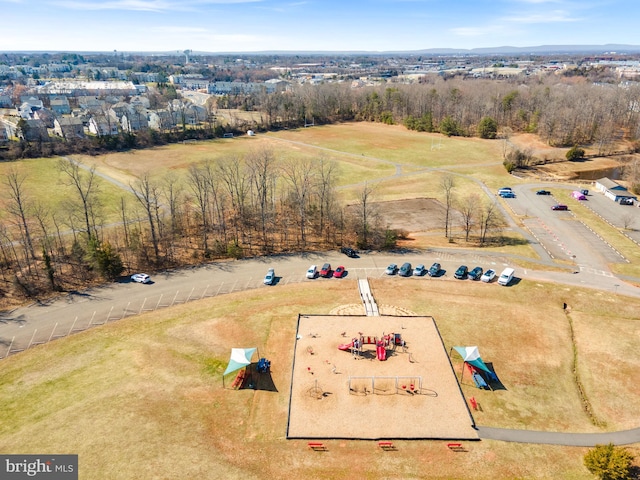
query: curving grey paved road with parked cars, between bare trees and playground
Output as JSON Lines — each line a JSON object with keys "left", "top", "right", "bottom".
{"left": 0, "top": 249, "right": 640, "bottom": 358}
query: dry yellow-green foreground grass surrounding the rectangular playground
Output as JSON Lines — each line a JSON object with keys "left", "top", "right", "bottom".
{"left": 0, "top": 278, "right": 640, "bottom": 479}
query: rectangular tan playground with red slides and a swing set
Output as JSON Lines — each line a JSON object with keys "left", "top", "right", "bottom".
{"left": 287, "top": 315, "right": 478, "bottom": 440}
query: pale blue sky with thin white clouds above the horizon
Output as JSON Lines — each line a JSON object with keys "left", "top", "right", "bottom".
{"left": 0, "top": 0, "right": 640, "bottom": 53}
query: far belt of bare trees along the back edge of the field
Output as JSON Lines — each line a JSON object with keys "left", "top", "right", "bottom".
{"left": 0, "top": 71, "right": 640, "bottom": 158}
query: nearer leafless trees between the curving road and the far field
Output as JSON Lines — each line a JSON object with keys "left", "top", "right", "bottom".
{"left": 0, "top": 149, "right": 510, "bottom": 304}
